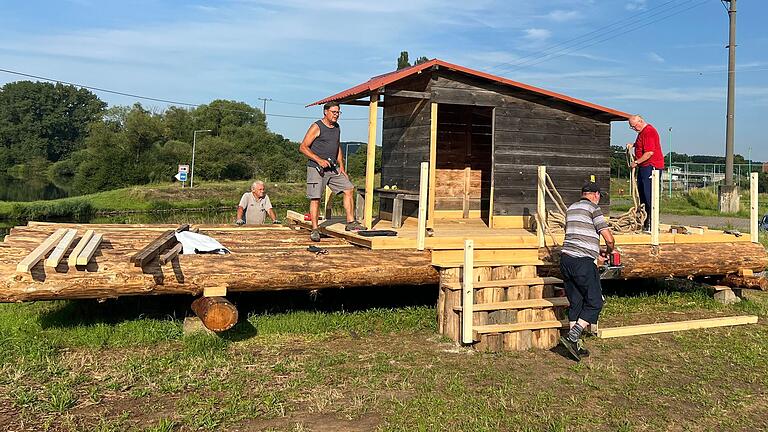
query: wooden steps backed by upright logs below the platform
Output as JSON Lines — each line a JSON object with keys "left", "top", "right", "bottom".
{"left": 437, "top": 265, "right": 568, "bottom": 352}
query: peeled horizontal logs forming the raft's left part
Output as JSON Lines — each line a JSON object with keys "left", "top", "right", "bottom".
{"left": 0, "top": 222, "right": 439, "bottom": 302}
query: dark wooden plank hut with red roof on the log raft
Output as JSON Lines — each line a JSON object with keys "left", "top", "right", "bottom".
{"left": 312, "top": 59, "right": 629, "bottom": 228}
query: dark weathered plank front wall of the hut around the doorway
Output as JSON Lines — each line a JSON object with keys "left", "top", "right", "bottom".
{"left": 430, "top": 70, "right": 610, "bottom": 215}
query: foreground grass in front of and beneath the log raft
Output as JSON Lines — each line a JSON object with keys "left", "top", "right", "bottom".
{"left": 0, "top": 281, "right": 768, "bottom": 431}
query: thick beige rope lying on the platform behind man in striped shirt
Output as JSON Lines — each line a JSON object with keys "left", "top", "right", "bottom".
{"left": 536, "top": 149, "right": 648, "bottom": 236}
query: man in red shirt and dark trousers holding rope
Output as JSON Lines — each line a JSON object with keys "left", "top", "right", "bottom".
{"left": 627, "top": 115, "right": 664, "bottom": 231}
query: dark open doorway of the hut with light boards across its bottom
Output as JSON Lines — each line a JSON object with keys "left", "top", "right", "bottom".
{"left": 435, "top": 104, "right": 493, "bottom": 225}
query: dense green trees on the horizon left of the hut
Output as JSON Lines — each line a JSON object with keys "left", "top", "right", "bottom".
{"left": 0, "top": 81, "right": 380, "bottom": 194}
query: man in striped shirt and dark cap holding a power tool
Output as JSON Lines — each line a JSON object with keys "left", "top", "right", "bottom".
{"left": 560, "top": 182, "right": 614, "bottom": 361}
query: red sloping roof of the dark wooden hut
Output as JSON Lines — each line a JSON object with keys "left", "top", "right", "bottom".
{"left": 307, "top": 59, "right": 630, "bottom": 119}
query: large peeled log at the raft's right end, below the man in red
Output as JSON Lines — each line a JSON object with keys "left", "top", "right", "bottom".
{"left": 540, "top": 242, "right": 768, "bottom": 279}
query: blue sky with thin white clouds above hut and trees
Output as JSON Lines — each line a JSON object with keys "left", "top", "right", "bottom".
{"left": 0, "top": 0, "right": 768, "bottom": 160}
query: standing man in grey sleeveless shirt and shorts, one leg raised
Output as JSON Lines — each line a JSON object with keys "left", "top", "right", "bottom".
{"left": 299, "top": 102, "right": 366, "bottom": 242}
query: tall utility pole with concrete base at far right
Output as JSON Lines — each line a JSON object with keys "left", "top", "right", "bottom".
{"left": 719, "top": 0, "right": 739, "bottom": 213}
